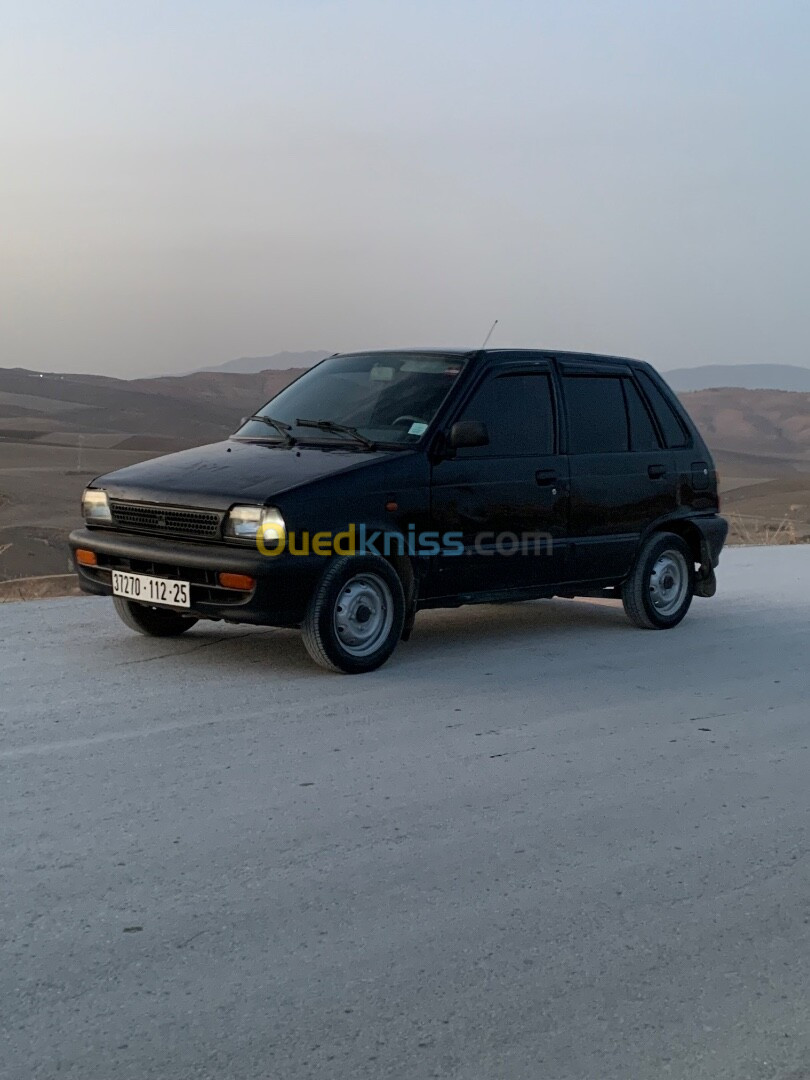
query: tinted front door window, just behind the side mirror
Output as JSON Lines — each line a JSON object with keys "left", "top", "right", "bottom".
{"left": 458, "top": 372, "right": 554, "bottom": 458}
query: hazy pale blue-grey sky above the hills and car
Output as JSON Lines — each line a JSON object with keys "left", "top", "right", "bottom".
{"left": 0, "top": 0, "right": 810, "bottom": 376}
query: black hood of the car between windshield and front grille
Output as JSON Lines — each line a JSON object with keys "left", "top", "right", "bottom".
{"left": 93, "top": 440, "right": 400, "bottom": 510}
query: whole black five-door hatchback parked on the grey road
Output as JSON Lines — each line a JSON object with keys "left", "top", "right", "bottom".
{"left": 70, "top": 349, "right": 728, "bottom": 672}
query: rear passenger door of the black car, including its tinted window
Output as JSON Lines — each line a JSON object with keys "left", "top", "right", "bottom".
{"left": 561, "top": 364, "right": 675, "bottom": 581}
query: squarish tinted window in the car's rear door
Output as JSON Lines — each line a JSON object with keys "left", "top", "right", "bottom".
{"left": 563, "top": 375, "right": 630, "bottom": 454}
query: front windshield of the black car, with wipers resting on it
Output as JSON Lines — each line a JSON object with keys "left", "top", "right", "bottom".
{"left": 237, "top": 353, "right": 465, "bottom": 448}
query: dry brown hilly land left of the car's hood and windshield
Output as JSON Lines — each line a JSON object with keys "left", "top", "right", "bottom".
{"left": 0, "top": 369, "right": 299, "bottom": 580}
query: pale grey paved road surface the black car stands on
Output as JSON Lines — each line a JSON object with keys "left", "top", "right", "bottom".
{"left": 0, "top": 549, "right": 810, "bottom": 1080}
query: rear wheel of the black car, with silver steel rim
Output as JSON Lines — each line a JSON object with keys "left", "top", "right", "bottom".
{"left": 622, "top": 532, "right": 694, "bottom": 630}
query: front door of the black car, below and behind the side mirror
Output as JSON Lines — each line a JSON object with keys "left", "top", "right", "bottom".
{"left": 429, "top": 362, "right": 568, "bottom": 596}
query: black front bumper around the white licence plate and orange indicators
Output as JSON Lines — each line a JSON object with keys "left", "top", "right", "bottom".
{"left": 68, "top": 528, "right": 325, "bottom": 626}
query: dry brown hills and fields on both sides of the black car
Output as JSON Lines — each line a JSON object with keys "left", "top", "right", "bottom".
{"left": 0, "top": 368, "right": 810, "bottom": 580}
